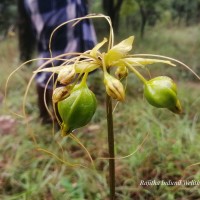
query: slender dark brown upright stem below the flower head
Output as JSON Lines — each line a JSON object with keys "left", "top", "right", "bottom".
{"left": 106, "top": 95, "right": 115, "bottom": 200}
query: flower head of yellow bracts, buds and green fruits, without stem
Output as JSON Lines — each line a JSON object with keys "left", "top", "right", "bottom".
{"left": 35, "top": 36, "right": 182, "bottom": 133}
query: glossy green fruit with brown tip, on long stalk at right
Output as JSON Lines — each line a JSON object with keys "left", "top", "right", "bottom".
{"left": 144, "top": 76, "right": 182, "bottom": 114}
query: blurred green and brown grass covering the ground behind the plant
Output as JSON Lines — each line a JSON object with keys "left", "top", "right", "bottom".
{"left": 0, "top": 24, "right": 200, "bottom": 200}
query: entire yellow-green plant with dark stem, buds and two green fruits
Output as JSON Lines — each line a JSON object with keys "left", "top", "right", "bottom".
{"left": 5, "top": 15, "right": 200, "bottom": 199}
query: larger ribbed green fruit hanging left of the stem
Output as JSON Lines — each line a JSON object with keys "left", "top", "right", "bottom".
{"left": 58, "top": 84, "right": 97, "bottom": 134}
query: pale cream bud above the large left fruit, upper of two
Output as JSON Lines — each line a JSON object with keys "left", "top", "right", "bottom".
{"left": 57, "top": 65, "right": 76, "bottom": 85}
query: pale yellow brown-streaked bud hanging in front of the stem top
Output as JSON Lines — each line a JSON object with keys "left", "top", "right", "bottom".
{"left": 104, "top": 73, "right": 125, "bottom": 101}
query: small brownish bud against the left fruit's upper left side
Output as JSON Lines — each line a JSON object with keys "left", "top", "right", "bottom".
{"left": 52, "top": 86, "right": 70, "bottom": 103}
